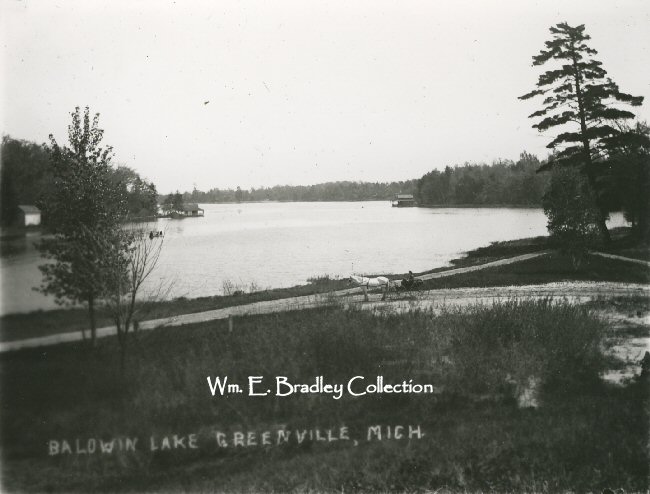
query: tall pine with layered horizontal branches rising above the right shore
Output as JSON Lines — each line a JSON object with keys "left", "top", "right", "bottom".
{"left": 520, "top": 23, "right": 643, "bottom": 242}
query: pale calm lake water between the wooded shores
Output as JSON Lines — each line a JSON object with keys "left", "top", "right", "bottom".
{"left": 0, "top": 202, "right": 625, "bottom": 314}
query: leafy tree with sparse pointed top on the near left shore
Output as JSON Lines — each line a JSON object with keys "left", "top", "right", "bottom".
{"left": 38, "top": 107, "right": 127, "bottom": 345}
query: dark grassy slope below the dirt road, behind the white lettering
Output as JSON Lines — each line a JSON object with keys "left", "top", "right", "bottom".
{"left": 0, "top": 301, "right": 649, "bottom": 492}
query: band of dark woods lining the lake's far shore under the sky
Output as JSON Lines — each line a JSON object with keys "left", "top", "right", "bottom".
{"left": 0, "top": 136, "right": 548, "bottom": 216}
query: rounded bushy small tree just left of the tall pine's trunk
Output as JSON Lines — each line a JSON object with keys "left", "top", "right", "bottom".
{"left": 542, "top": 167, "right": 599, "bottom": 270}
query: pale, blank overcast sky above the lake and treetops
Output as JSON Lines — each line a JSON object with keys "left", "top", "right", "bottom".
{"left": 0, "top": 0, "right": 650, "bottom": 193}
